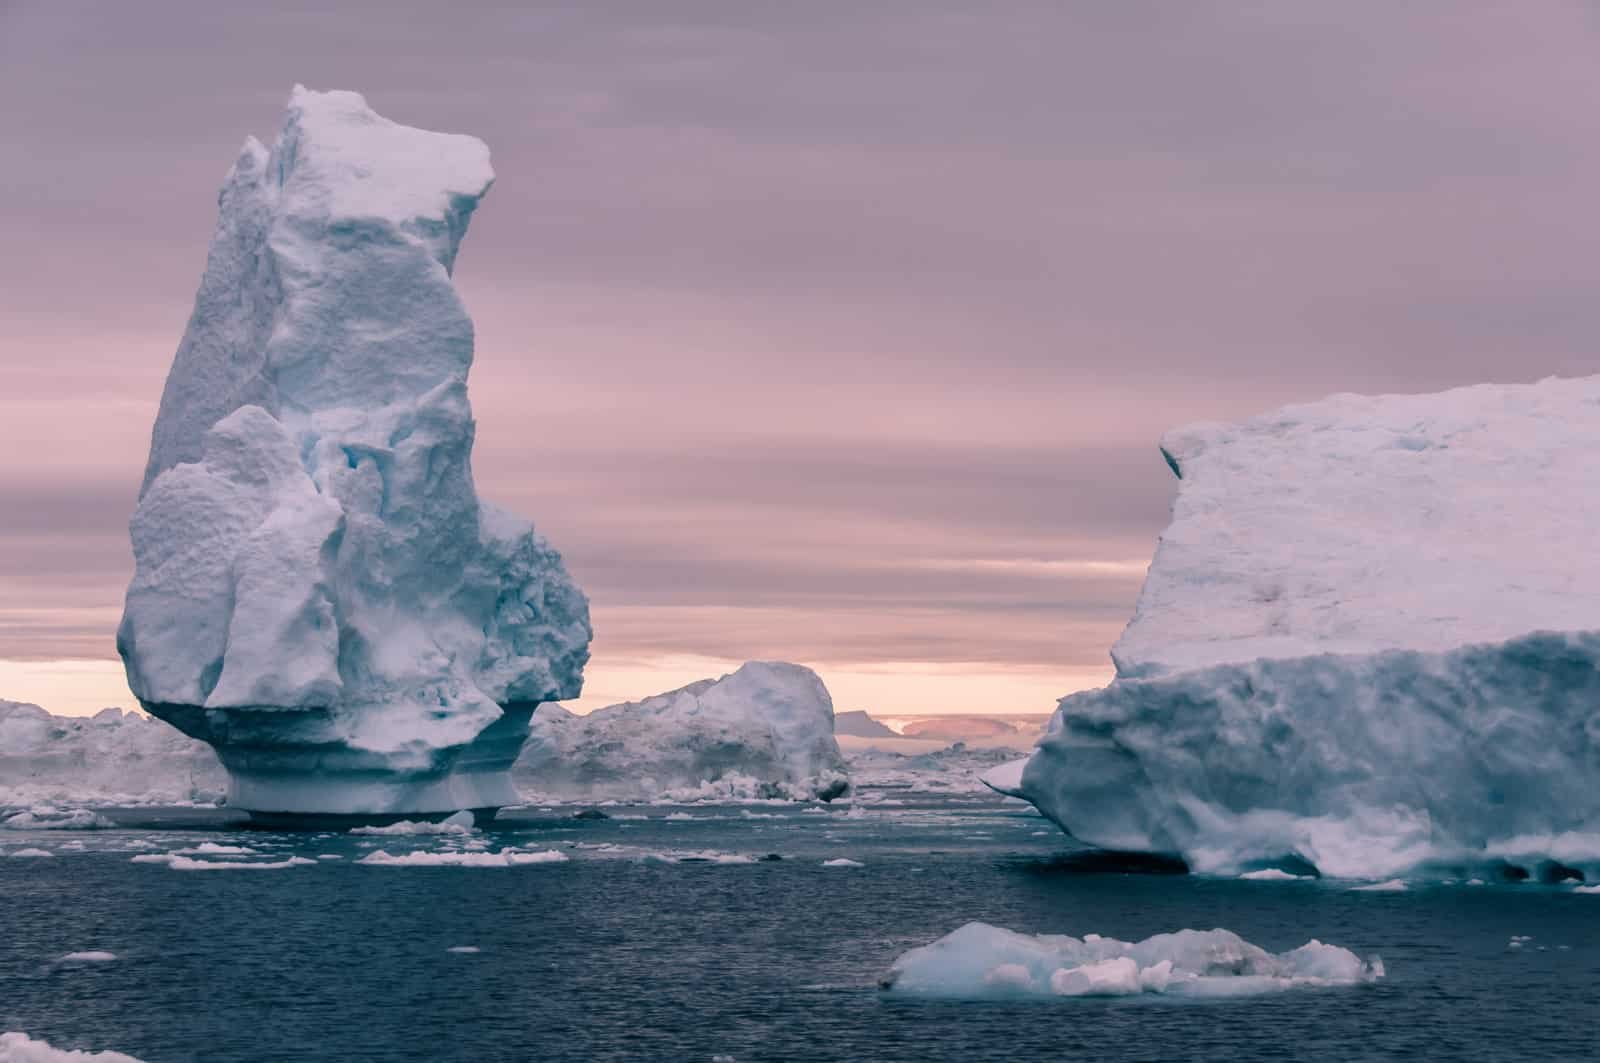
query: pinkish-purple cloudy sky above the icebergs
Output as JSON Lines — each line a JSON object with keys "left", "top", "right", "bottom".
{"left": 0, "top": 0, "right": 1600, "bottom": 714}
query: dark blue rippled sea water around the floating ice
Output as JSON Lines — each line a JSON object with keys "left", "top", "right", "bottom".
{"left": 0, "top": 796, "right": 1600, "bottom": 1063}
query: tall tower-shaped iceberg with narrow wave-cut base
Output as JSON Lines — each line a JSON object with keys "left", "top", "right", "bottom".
{"left": 118, "top": 88, "right": 590, "bottom": 813}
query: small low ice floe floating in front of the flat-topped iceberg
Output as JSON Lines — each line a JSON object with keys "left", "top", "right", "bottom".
{"left": 883, "top": 922, "right": 1384, "bottom": 997}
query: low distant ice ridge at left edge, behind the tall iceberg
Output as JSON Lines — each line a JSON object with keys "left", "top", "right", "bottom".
{"left": 0, "top": 701, "right": 227, "bottom": 806}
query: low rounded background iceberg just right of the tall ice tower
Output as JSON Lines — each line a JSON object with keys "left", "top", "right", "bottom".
{"left": 514, "top": 661, "right": 850, "bottom": 800}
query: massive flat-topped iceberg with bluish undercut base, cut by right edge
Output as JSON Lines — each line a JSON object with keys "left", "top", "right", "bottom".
{"left": 1018, "top": 376, "right": 1600, "bottom": 876}
